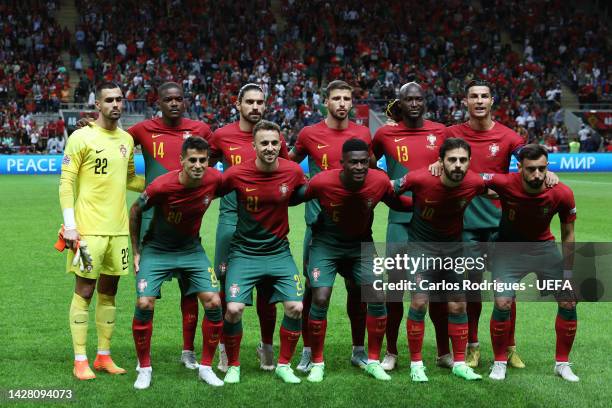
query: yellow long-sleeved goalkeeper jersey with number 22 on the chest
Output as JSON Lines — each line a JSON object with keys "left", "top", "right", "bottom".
{"left": 59, "top": 124, "right": 144, "bottom": 235}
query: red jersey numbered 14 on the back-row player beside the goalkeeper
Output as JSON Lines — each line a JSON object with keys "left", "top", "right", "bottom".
{"left": 128, "top": 118, "right": 212, "bottom": 184}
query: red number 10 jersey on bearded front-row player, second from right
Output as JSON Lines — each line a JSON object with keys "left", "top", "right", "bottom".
{"left": 394, "top": 168, "right": 486, "bottom": 242}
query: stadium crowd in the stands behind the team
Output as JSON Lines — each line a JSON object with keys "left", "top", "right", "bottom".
{"left": 0, "top": 0, "right": 610, "bottom": 151}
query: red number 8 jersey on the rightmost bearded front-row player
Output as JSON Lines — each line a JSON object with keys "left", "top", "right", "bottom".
{"left": 485, "top": 173, "right": 576, "bottom": 242}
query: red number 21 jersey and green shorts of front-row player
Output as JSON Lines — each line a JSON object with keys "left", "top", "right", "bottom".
{"left": 222, "top": 159, "right": 306, "bottom": 304}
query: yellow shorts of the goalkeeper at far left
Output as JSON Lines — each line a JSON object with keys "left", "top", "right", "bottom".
{"left": 66, "top": 235, "right": 130, "bottom": 279}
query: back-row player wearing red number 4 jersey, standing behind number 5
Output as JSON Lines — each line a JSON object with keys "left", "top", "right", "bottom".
{"left": 289, "top": 80, "right": 376, "bottom": 372}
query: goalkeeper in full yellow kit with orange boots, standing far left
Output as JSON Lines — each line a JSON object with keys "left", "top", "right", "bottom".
{"left": 59, "top": 82, "right": 144, "bottom": 380}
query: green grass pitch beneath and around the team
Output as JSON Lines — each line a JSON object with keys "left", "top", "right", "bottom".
{"left": 0, "top": 173, "right": 612, "bottom": 408}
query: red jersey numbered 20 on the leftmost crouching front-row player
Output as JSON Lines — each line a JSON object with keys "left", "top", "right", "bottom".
{"left": 140, "top": 168, "right": 221, "bottom": 251}
